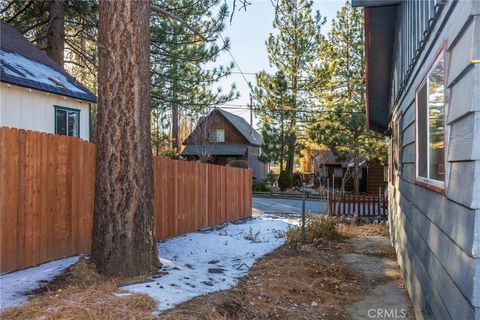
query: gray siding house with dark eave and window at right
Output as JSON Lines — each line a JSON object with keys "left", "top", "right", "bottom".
{"left": 352, "top": 0, "right": 480, "bottom": 320}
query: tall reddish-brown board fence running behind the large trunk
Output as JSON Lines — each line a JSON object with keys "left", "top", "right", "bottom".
{"left": 0, "top": 127, "right": 252, "bottom": 272}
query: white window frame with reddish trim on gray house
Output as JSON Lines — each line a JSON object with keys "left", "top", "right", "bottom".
{"left": 415, "top": 46, "right": 448, "bottom": 194}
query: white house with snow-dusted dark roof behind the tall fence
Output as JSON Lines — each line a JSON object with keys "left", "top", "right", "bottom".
{"left": 0, "top": 22, "right": 96, "bottom": 140}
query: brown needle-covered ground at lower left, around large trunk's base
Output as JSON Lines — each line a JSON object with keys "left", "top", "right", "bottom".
{"left": 0, "top": 258, "right": 156, "bottom": 320}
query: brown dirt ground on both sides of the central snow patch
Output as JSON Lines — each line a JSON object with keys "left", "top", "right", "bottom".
{"left": 1, "top": 225, "right": 414, "bottom": 320}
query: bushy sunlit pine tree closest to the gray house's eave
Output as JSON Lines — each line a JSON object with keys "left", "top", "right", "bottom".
{"left": 309, "top": 3, "right": 386, "bottom": 193}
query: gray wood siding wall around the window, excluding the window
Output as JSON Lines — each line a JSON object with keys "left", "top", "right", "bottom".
{"left": 389, "top": 1, "right": 480, "bottom": 319}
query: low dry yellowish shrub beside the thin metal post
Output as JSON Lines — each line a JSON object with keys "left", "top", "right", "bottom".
{"left": 286, "top": 216, "right": 340, "bottom": 245}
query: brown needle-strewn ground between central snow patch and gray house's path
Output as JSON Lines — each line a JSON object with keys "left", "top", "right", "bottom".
{"left": 162, "top": 245, "right": 365, "bottom": 320}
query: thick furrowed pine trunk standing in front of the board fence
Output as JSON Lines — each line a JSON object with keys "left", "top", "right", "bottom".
{"left": 92, "top": 0, "right": 160, "bottom": 276}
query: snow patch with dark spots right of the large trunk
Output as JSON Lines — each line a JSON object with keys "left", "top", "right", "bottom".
{"left": 122, "top": 217, "right": 289, "bottom": 311}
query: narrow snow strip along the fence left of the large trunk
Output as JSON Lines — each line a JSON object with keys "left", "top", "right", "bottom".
{"left": 0, "top": 257, "right": 78, "bottom": 312}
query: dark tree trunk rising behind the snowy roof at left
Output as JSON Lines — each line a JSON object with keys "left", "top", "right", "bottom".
{"left": 45, "top": 0, "right": 65, "bottom": 68}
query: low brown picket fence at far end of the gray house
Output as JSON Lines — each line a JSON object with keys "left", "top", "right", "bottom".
{"left": 328, "top": 192, "right": 388, "bottom": 219}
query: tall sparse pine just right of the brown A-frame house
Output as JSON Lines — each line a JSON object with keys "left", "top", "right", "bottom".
{"left": 257, "top": 0, "right": 325, "bottom": 174}
